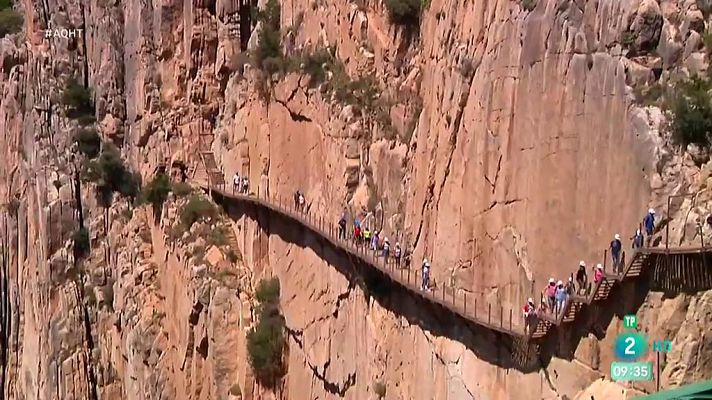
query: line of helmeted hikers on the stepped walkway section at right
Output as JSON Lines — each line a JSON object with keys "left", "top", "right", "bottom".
{"left": 523, "top": 208, "right": 655, "bottom": 333}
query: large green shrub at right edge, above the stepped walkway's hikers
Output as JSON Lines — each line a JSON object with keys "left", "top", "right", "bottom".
{"left": 666, "top": 76, "right": 712, "bottom": 147}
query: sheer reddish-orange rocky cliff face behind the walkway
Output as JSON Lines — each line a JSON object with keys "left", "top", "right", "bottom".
{"left": 0, "top": 0, "right": 712, "bottom": 399}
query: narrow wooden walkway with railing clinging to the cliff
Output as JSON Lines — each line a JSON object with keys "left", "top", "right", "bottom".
{"left": 196, "top": 182, "right": 712, "bottom": 342}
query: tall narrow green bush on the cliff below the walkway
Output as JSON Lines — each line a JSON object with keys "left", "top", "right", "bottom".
{"left": 247, "top": 278, "right": 286, "bottom": 388}
